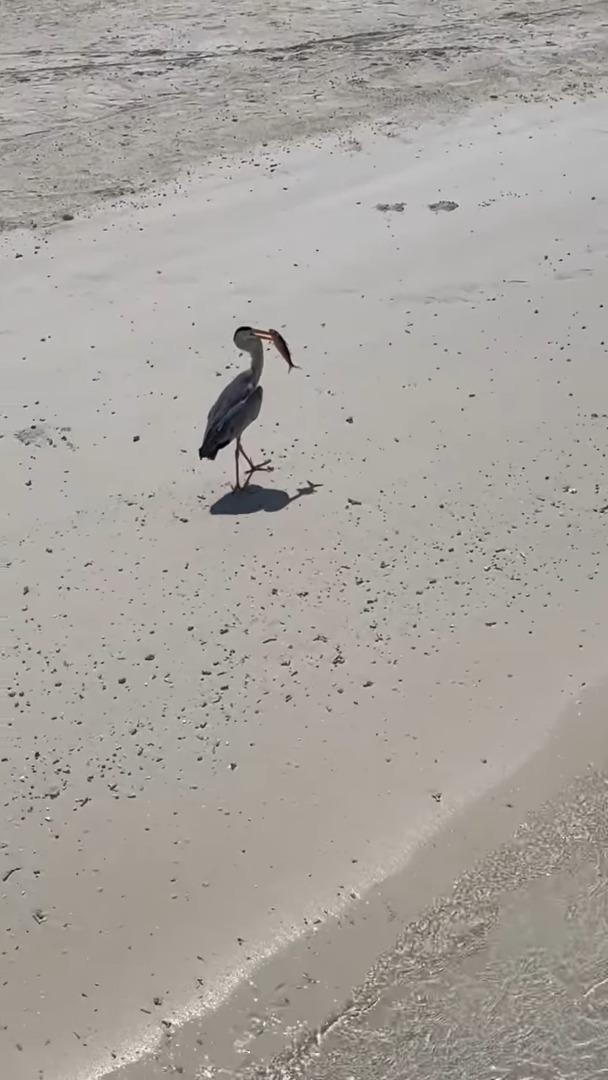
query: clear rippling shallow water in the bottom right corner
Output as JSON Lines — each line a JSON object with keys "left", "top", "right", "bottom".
{"left": 257, "top": 773, "right": 608, "bottom": 1080}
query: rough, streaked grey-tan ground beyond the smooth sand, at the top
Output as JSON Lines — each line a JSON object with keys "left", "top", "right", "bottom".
{"left": 0, "top": 0, "right": 608, "bottom": 228}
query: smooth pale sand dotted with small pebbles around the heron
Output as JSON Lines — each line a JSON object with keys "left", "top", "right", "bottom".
{"left": 0, "top": 2, "right": 608, "bottom": 1080}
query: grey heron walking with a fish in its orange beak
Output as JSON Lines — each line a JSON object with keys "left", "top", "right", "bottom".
{"left": 199, "top": 326, "right": 297, "bottom": 491}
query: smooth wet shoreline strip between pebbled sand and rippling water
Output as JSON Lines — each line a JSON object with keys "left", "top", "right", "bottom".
{"left": 103, "top": 683, "right": 608, "bottom": 1080}
